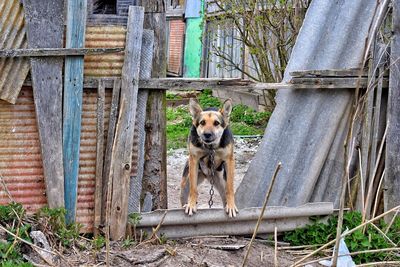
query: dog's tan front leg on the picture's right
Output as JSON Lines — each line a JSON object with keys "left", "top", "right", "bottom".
{"left": 225, "top": 152, "right": 238, "bottom": 217}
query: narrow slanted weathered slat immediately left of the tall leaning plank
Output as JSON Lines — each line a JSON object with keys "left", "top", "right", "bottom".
{"left": 101, "top": 79, "right": 121, "bottom": 224}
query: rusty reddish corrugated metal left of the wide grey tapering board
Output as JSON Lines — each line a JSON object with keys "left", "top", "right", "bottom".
{"left": 0, "top": 87, "right": 47, "bottom": 213}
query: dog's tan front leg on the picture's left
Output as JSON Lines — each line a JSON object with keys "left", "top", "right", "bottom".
{"left": 184, "top": 155, "right": 199, "bottom": 216}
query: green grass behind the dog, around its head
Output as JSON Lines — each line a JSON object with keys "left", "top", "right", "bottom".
{"left": 167, "top": 90, "right": 271, "bottom": 150}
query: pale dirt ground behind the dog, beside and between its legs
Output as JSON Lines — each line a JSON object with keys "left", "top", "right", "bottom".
{"left": 167, "top": 138, "right": 261, "bottom": 209}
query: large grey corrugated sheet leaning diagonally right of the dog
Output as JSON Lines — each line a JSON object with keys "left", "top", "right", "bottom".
{"left": 236, "top": 0, "right": 377, "bottom": 207}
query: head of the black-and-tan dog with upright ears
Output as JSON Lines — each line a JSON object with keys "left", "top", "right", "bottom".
{"left": 189, "top": 98, "right": 232, "bottom": 145}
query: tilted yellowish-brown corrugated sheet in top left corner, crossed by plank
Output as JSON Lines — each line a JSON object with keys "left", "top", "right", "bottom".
{"left": 0, "top": 0, "right": 30, "bottom": 104}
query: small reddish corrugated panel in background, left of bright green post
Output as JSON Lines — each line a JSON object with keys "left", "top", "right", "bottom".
{"left": 168, "top": 19, "right": 185, "bottom": 75}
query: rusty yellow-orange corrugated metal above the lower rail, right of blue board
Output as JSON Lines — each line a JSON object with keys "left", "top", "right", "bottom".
{"left": 84, "top": 26, "right": 126, "bottom": 77}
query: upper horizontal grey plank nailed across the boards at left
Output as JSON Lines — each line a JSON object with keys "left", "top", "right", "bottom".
{"left": 0, "top": 47, "right": 124, "bottom": 58}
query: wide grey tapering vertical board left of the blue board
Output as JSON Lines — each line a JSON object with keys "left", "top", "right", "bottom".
{"left": 24, "top": 0, "right": 64, "bottom": 208}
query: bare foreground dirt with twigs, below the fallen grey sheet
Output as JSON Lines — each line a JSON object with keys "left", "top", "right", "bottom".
{"left": 43, "top": 237, "right": 304, "bottom": 267}
